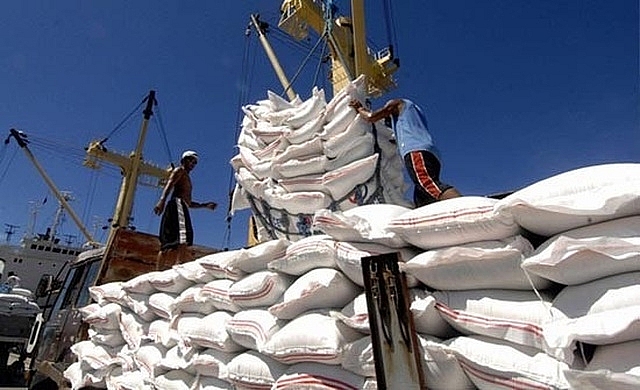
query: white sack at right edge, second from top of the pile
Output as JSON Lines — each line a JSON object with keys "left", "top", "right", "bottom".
{"left": 522, "top": 216, "right": 640, "bottom": 285}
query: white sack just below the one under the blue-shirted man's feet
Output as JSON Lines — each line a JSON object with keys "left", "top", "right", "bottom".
{"left": 399, "top": 236, "right": 552, "bottom": 290}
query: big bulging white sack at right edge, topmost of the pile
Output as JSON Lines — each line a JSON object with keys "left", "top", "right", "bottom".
{"left": 496, "top": 163, "right": 640, "bottom": 236}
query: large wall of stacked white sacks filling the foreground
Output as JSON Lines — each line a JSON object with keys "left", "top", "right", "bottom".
{"left": 66, "top": 164, "right": 640, "bottom": 389}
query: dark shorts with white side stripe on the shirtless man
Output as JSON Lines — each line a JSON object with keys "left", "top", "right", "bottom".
{"left": 159, "top": 198, "right": 193, "bottom": 251}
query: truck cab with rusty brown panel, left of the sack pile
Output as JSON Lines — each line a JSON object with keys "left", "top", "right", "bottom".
{"left": 30, "top": 228, "right": 217, "bottom": 390}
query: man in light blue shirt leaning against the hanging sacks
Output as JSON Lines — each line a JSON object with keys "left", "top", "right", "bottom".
{"left": 349, "top": 99, "right": 461, "bottom": 207}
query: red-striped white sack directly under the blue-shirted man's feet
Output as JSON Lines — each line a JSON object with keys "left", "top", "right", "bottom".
{"left": 386, "top": 196, "right": 520, "bottom": 249}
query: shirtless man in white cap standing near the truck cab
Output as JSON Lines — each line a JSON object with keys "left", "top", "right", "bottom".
{"left": 153, "top": 150, "right": 217, "bottom": 270}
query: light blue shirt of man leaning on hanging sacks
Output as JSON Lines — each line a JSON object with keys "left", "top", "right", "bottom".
{"left": 392, "top": 99, "right": 440, "bottom": 160}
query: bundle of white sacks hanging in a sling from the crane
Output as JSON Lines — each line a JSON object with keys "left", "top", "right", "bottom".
{"left": 231, "top": 77, "right": 410, "bottom": 241}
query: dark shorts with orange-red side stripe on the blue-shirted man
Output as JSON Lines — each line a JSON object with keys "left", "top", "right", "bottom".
{"left": 404, "top": 150, "right": 452, "bottom": 207}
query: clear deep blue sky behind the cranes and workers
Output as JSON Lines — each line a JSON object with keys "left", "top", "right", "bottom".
{"left": 0, "top": 0, "right": 640, "bottom": 247}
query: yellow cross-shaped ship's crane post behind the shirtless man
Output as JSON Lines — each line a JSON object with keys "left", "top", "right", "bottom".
{"left": 85, "top": 90, "right": 171, "bottom": 242}
